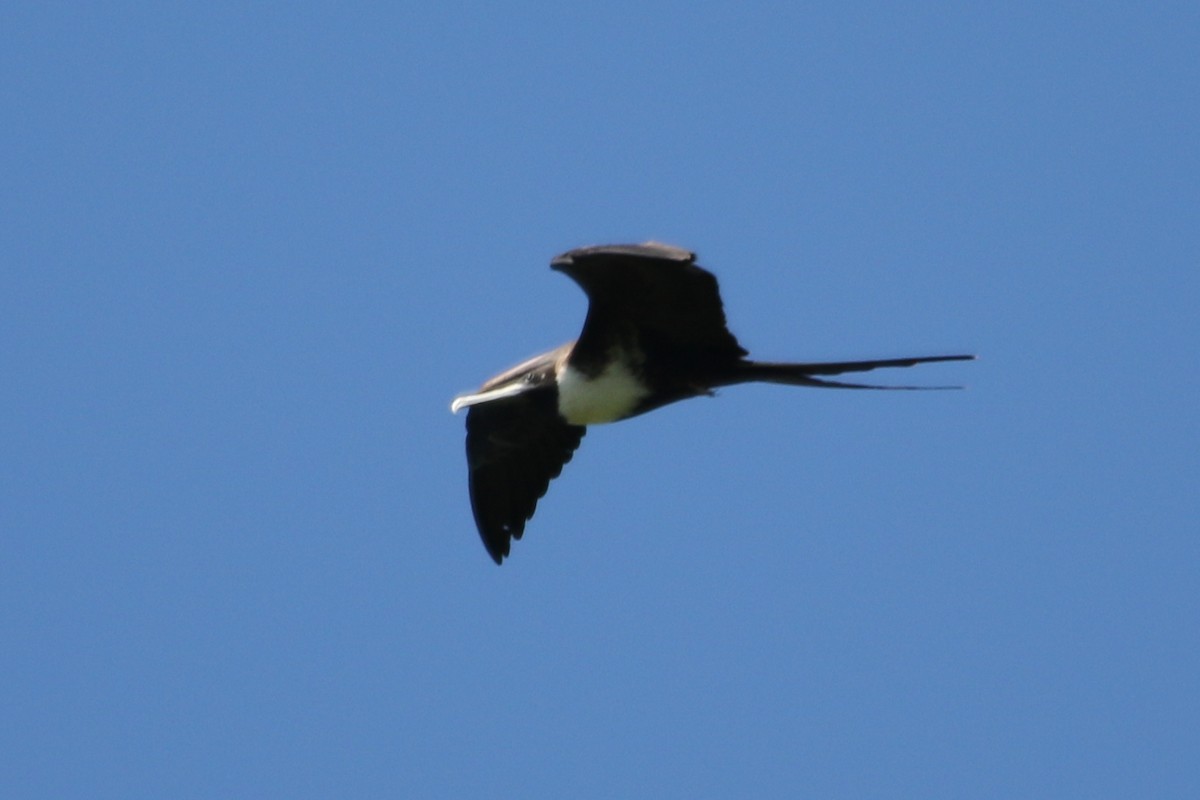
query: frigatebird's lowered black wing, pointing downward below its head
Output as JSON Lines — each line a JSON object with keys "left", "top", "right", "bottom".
{"left": 467, "top": 387, "right": 587, "bottom": 564}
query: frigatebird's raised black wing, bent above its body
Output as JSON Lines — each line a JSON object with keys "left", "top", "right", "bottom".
{"left": 551, "top": 242, "right": 746, "bottom": 361}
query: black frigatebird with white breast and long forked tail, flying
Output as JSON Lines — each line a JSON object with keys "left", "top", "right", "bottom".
{"left": 450, "top": 242, "right": 974, "bottom": 564}
